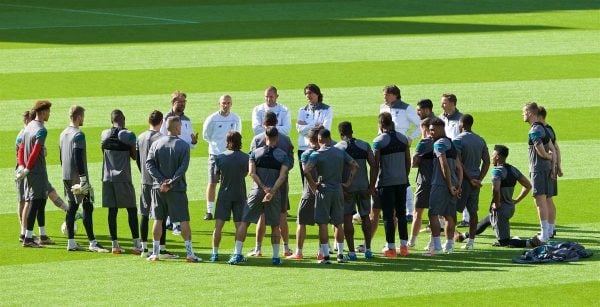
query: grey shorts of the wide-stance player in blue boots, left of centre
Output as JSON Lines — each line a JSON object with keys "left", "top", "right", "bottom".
{"left": 242, "top": 189, "right": 281, "bottom": 226}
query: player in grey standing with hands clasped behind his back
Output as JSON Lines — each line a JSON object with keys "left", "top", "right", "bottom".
{"left": 145, "top": 116, "right": 202, "bottom": 262}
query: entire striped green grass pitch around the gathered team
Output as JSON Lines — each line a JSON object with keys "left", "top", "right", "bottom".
{"left": 0, "top": 0, "right": 600, "bottom": 306}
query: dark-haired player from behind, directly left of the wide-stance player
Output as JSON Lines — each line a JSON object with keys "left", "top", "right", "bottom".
{"left": 210, "top": 131, "right": 249, "bottom": 262}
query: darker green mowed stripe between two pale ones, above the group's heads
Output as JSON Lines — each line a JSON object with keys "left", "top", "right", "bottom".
{"left": 0, "top": 54, "right": 600, "bottom": 100}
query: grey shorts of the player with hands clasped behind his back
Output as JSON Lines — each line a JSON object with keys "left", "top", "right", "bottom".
{"left": 151, "top": 189, "right": 190, "bottom": 223}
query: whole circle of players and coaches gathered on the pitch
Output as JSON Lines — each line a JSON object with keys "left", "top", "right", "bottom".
{"left": 16, "top": 84, "right": 562, "bottom": 265}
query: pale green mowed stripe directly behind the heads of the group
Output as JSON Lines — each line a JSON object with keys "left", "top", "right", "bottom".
{"left": 0, "top": 78, "right": 600, "bottom": 134}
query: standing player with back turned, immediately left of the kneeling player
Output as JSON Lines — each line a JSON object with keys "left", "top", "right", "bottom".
{"left": 452, "top": 114, "right": 490, "bottom": 249}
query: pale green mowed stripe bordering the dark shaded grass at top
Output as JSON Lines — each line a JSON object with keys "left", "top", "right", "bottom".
{"left": 0, "top": 30, "right": 600, "bottom": 74}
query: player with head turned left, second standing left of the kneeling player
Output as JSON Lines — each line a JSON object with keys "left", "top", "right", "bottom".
{"left": 425, "top": 118, "right": 463, "bottom": 256}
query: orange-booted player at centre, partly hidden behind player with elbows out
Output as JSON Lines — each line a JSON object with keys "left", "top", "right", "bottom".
{"left": 286, "top": 128, "right": 323, "bottom": 260}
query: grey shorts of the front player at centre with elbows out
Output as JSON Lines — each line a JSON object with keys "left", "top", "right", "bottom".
{"left": 315, "top": 190, "right": 344, "bottom": 225}
